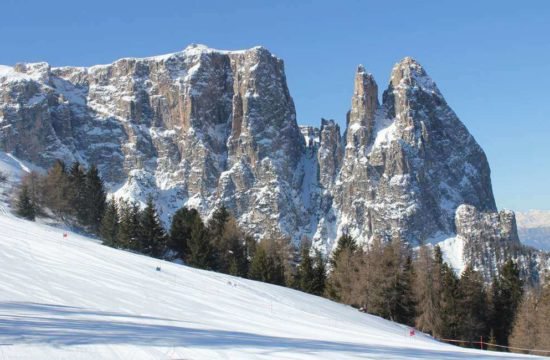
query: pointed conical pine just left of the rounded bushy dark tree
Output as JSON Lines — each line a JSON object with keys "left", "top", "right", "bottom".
{"left": 139, "top": 196, "right": 166, "bottom": 258}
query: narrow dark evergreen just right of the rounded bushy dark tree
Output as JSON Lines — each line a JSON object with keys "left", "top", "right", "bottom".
{"left": 187, "top": 213, "right": 214, "bottom": 269}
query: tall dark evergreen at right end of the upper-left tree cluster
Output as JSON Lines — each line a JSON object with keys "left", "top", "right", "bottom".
{"left": 83, "top": 165, "right": 107, "bottom": 233}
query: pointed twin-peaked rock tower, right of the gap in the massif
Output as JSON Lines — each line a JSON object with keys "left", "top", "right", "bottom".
{"left": 330, "top": 58, "right": 496, "bottom": 248}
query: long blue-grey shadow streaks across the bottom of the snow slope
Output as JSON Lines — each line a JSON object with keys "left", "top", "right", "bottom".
{"left": 0, "top": 302, "right": 508, "bottom": 359}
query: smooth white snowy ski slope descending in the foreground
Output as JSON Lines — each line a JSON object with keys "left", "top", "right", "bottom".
{"left": 0, "top": 215, "right": 544, "bottom": 359}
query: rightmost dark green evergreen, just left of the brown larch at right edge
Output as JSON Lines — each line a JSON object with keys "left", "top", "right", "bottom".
{"left": 491, "top": 260, "right": 523, "bottom": 346}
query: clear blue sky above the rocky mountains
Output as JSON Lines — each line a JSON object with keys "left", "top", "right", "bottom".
{"left": 0, "top": 0, "right": 550, "bottom": 210}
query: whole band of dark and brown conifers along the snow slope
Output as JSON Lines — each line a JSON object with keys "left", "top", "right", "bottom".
{"left": 12, "top": 161, "right": 550, "bottom": 349}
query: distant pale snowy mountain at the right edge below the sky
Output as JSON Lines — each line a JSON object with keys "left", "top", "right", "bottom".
{"left": 516, "top": 210, "right": 550, "bottom": 251}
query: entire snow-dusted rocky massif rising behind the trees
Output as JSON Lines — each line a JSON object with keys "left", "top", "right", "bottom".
{"left": 0, "top": 45, "right": 547, "bottom": 278}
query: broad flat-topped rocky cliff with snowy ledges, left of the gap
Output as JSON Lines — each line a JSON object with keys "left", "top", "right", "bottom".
{"left": 0, "top": 46, "right": 305, "bottom": 239}
